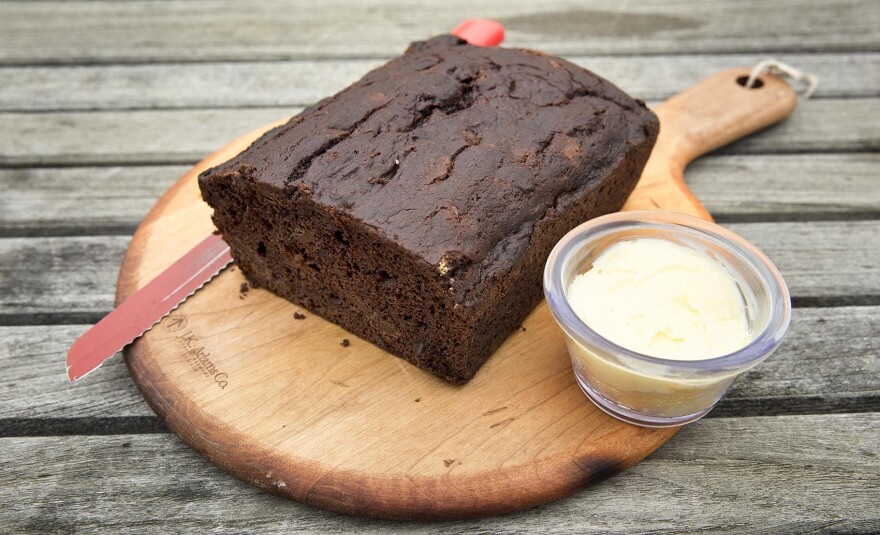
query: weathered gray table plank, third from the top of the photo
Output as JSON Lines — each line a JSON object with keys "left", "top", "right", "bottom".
{"left": 0, "top": 98, "right": 880, "bottom": 167}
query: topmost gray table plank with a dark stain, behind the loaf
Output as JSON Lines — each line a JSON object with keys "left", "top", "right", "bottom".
{"left": 0, "top": 0, "right": 880, "bottom": 64}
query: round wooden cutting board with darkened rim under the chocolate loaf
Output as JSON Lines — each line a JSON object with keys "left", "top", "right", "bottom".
{"left": 117, "top": 72, "right": 793, "bottom": 518}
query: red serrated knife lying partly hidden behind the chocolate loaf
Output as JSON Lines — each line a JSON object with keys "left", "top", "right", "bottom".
{"left": 67, "top": 19, "right": 504, "bottom": 382}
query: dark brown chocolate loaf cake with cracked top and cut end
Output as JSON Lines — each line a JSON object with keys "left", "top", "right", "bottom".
{"left": 199, "top": 36, "right": 659, "bottom": 383}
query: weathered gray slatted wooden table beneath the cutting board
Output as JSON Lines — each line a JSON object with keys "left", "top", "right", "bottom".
{"left": 0, "top": 0, "right": 880, "bottom": 533}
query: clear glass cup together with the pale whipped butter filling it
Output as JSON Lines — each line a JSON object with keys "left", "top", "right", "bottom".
{"left": 544, "top": 210, "right": 791, "bottom": 427}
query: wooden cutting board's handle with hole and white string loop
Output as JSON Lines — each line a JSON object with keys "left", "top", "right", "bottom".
{"left": 623, "top": 68, "right": 797, "bottom": 221}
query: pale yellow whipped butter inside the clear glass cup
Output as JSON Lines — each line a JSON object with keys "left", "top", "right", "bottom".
{"left": 566, "top": 238, "right": 752, "bottom": 360}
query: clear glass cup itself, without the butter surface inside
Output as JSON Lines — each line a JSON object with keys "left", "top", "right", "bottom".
{"left": 544, "top": 211, "right": 791, "bottom": 427}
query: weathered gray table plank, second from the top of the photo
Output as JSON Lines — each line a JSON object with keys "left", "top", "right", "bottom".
{"left": 0, "top": 53, "right": 880, "bottom": 111}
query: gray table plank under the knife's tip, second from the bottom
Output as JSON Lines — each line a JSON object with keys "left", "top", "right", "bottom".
{"left": 0, "top": 306, "right": 880, "bottom": 428}
